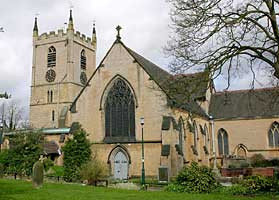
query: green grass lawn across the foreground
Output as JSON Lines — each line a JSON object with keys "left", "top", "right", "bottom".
{"left": 0, "top": 179, "right": 279, "bottom": 200}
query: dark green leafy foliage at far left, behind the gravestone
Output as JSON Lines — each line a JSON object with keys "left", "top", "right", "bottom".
{"left": 0, "top": 132, "right": 44, "bottom": 176}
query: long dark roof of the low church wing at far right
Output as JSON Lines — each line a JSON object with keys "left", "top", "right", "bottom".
{"left": 209, "top": 87, "right": 279, "bottom": 120}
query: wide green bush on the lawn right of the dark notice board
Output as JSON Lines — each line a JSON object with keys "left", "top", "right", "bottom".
{"left": 166, "top": 162, "right": 219, "bottom": 193}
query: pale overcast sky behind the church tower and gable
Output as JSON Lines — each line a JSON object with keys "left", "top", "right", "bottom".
{"left": 0, "top": 0, "right": 276, "bottom": 118}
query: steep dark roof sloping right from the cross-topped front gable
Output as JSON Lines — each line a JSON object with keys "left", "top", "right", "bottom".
{"left": 124, "top": 42, "right": 208, "bottom": 117}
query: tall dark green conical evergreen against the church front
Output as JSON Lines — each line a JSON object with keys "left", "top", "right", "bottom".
{"left": 63, "top": 122, "right": 91, "bottom": 182}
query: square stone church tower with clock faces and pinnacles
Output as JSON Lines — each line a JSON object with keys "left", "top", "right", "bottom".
{"left": 30, "top": 10, "right": 97, "bottom": 128}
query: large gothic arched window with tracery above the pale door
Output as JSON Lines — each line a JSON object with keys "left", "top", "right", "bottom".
{"left": 105, "top": 79, "right": 135, "bottom": 143}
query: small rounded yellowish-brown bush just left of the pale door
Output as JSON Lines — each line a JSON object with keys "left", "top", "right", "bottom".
{"left": 79, "top": 159, "right": 108, "bottom": 186}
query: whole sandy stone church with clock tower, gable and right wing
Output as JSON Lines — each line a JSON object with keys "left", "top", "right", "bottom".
{"left": 30, "top": 12, "right": 279, "bottom": 179}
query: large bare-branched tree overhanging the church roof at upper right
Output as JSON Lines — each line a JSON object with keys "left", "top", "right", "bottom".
{"left": 166, "top": 0, "right": 279, "bottom": 86}
